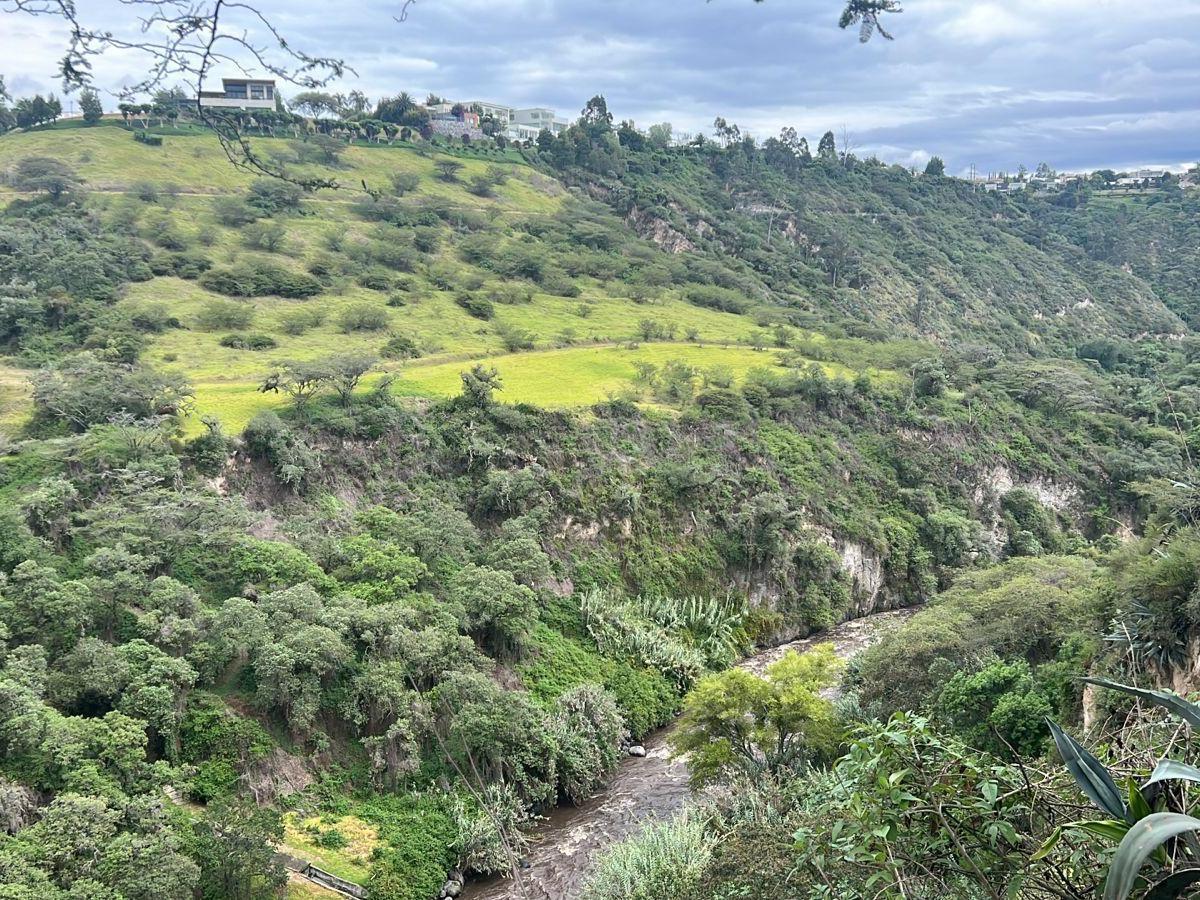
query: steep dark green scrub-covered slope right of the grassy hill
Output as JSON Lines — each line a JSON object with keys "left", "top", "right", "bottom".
{"left": 582, "top": 148, "right": 1183, "bottom": 356}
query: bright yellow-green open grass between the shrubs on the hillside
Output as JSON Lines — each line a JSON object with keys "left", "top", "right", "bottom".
{"left": 0, "top": 124, "right": 907, "bottom": 432}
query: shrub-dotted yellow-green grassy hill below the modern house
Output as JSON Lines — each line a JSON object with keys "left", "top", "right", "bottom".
{"left": 0, "top": 127, "right": 796, "bottom": 430}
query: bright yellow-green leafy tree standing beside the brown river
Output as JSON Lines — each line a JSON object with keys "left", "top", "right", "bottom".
{"left": 671, "top": 644, "right": 840, "bottom": 785}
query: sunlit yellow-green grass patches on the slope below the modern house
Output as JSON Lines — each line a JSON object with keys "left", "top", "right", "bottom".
{"left": 0, "top": 127, "right": 835, "bottom": 430}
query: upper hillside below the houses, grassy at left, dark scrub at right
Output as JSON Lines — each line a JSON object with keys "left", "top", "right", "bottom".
{"left": 0, "top": 120, "right": 1183, "bottom": 431}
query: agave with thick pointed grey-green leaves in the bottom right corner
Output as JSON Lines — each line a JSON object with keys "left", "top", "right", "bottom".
{"left": 1033, "top": 678, "right": 1200, "bottom": 900}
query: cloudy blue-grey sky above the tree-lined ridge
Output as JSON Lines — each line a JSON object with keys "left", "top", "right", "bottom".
{"left": 0, "top": 0, "right": 1200, "bottom": 174}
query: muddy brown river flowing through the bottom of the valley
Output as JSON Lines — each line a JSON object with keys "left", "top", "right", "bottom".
{"left": 462, "top": 610, "right": 913, "bottom": 900}
